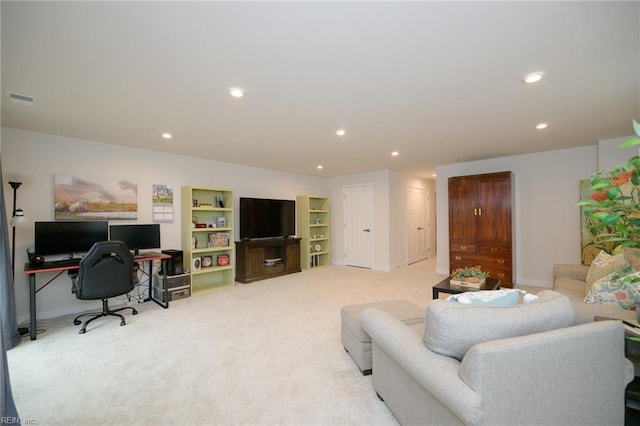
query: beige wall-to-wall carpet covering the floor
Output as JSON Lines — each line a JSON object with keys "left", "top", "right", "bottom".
{"left": 8, "top": 258, "right": 443, "bottom": 425}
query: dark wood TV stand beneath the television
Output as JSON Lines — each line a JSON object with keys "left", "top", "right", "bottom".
{"left": 236, "top": 238, "right": 302, "bottom": 284}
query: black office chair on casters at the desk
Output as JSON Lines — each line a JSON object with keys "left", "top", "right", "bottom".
{"left": 69, "top": 241, "right": 138, "bottom": 334}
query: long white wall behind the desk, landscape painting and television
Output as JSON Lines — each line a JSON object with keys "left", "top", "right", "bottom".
{"left": 2, "top": 127, "right": 327, "bottom": 322}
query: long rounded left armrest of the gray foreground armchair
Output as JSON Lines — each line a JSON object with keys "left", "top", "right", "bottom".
{"left": 360, "top": 308, "right": 482, "bottom": 424}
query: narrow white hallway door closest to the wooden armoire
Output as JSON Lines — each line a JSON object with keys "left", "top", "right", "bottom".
{"left": 407, "top": 186, "right": 429, "bottom": 263}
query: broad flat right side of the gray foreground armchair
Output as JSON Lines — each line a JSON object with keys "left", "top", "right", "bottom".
{"left": 460, "top": 321, "right": 632, "bottom": 424}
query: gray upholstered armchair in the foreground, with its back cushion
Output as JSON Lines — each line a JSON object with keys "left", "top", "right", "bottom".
{"left": 361, "top": 290, "right": 633, "bottom": 425}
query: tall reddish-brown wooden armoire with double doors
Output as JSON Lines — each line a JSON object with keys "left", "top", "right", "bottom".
{"left": 449, "top": 172, "right": 515, "bottom": 287}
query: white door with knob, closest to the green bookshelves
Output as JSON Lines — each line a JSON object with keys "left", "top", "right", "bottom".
{"left": 344, "top": 184, "right": 373, "bottom": 268}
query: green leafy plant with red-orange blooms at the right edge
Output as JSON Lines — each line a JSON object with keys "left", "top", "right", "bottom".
{"left": 578, "top": 120, "right": 640, "bottom": 253}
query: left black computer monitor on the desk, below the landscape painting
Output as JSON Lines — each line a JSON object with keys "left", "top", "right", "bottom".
{"left": 34, "top": 220, "right": 109, "bottom": 258}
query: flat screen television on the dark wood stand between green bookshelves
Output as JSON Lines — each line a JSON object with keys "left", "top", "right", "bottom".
{"left": 240, "top": 197, "right": 296, "bottom": 239}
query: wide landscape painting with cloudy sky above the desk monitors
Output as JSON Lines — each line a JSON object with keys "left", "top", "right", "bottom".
{"left": 53, "top": 174, "right": 138, "bottom": 220}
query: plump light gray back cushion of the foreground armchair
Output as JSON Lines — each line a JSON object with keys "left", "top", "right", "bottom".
{"left": 423, "top": 290, "right": 574, "bottom": 360}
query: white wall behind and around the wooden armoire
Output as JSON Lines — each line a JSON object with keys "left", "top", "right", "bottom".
{"left": 436, "top": 146, "right": 597, "bottom": 287}
